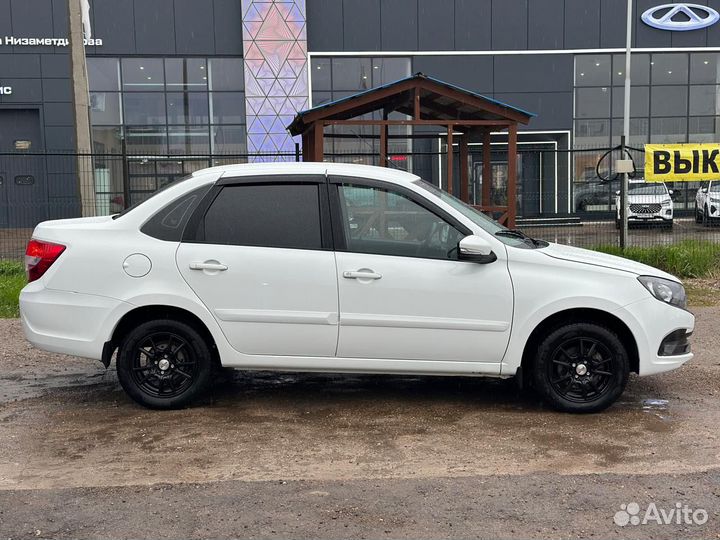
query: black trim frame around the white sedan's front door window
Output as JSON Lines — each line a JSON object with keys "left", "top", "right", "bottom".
{"left": 328, "top": 176, "right": 473, "bottom": 256}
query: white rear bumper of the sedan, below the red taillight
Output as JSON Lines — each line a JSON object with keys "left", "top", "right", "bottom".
{"left": 20, "top": 281, "right": 131, "bottom": 360}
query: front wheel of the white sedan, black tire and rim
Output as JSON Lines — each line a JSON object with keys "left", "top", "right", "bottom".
{"left": 533, "top": 322, "right": 630, "bottom": 413}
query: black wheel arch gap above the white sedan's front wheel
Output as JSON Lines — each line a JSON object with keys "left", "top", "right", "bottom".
{"left": 520, "top": 308, "right": 640, "bottom": 383}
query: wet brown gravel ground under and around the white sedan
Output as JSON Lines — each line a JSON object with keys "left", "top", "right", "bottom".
{"left": 0, "top": 307, "right": 720, "bottom": 538}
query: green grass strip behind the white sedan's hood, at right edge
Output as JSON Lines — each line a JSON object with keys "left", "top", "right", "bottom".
{"left": 595, "top": 240, "right": 720, "bottom": 278}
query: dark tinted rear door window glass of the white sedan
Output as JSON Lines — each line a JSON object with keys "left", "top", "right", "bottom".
{"left": 203, "top": 184, "right": 322, "bottom": 249}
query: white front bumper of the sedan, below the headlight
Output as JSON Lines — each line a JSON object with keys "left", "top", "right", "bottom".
{"left": 616, "top": 296, "right": 695, "bottom": 376}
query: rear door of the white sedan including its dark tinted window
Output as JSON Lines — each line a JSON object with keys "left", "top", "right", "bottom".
{"left": 177, "top": 176, "right": 338, "bottom": 357}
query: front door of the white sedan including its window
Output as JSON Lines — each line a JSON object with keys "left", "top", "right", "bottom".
{"left": 330, "top": 179, "right": 513, "bottom": 373}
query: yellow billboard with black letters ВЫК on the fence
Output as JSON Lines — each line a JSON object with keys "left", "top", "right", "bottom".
{"left": 645, "top": 143, "right": 720, "bottom": 182}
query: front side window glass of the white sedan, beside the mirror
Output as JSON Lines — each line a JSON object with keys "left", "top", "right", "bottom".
{"left": 338, "top": 184, "right": 465, "bottom": 260}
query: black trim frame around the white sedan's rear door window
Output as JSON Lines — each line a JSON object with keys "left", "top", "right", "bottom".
{"left": 181, "top": 174, "right": 333, "bottom": 251}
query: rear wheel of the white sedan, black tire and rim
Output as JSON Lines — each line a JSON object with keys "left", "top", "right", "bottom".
{"left": 117, "top": 319, "right": 213, "bottom": 409}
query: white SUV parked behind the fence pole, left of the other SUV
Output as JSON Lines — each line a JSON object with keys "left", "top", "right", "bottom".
{"left": 615, "top": 180, "right": 674, "bottom": 228}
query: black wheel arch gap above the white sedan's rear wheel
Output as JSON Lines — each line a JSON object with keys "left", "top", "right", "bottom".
{"left": 101, "top": 304, "right": 221, "bottom": 367}
